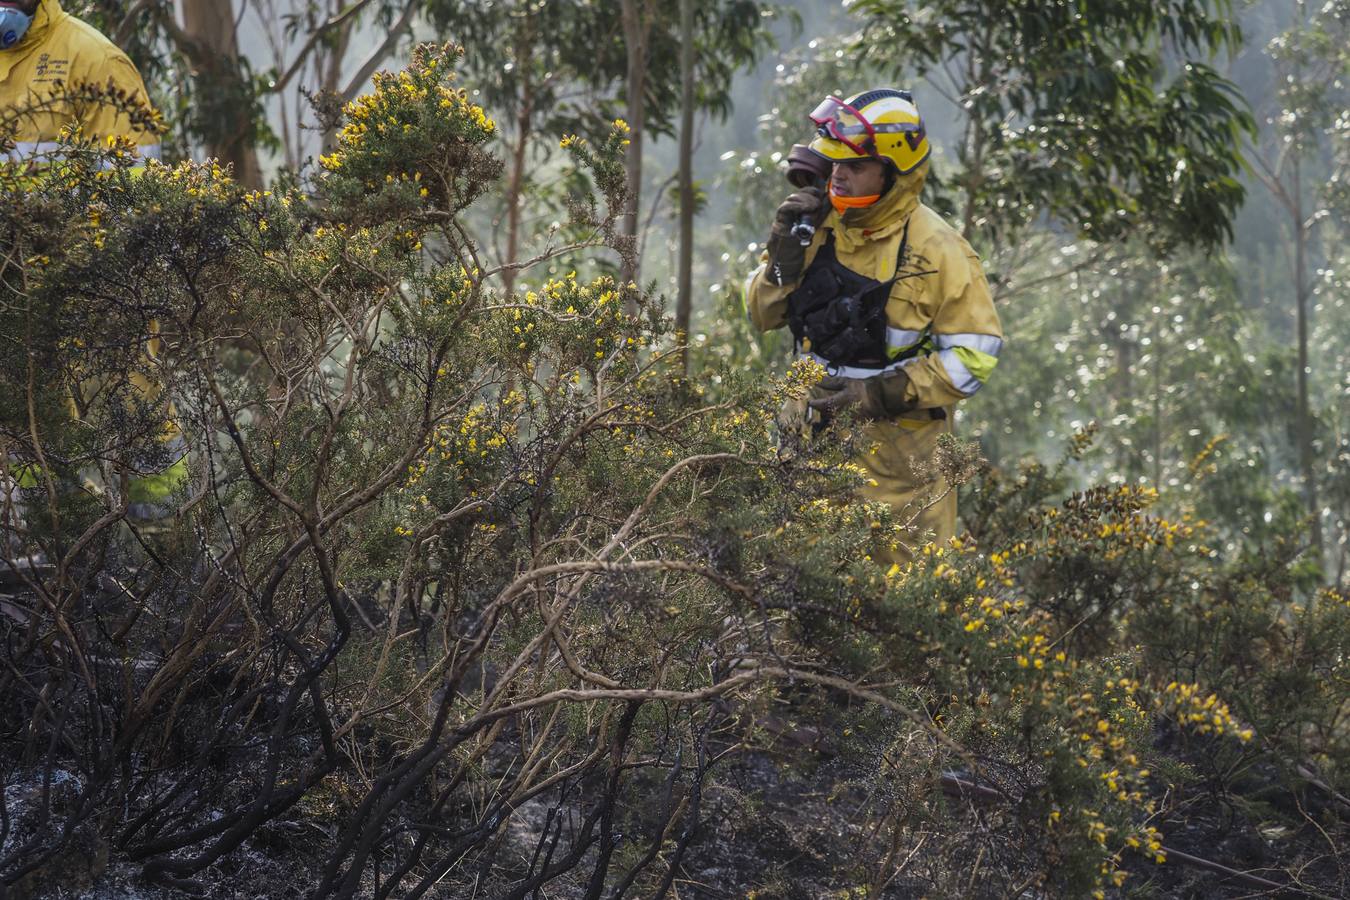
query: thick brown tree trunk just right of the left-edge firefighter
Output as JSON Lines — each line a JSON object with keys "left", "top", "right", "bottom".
{"left": 182, "top": 0, "right": 262, "bottom": 189}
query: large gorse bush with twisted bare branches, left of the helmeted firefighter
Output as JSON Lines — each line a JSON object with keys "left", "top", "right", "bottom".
{"left": 4, "top": 42, "right": 874, "bottom": 896}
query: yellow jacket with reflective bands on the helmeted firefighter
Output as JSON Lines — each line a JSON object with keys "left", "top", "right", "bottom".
{"left": 745, "top": 163, "right": 1003, "bottom": 409}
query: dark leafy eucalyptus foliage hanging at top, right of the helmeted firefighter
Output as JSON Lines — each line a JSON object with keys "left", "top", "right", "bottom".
{"left": 851, "top": 0, "right": 1251, "bottom": 275}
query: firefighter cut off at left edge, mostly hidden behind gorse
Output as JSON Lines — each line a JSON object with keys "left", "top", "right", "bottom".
{"left": 0, "top": 0, "right": 186, "bottom": 518}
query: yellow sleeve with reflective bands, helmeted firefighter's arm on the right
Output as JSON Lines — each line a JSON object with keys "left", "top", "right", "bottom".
{"left": 905, "top": 239, "right": 1003, "bottom": 409}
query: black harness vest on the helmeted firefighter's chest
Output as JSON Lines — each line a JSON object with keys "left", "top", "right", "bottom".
{"left": 787, "top": 221, "right": 910, "bottom": 368}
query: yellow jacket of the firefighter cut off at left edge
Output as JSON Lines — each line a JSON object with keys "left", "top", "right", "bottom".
{"left": 0, "top": 0, "right": 159, "bottom": 161}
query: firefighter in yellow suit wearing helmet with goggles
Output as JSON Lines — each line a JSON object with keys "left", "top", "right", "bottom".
{"left": 747, "top": 89, "right": 1003, "bottom": 561}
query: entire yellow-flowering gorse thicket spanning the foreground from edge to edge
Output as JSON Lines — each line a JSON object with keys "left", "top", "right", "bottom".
{"left": 0, "top": 47, "right": 1350, "bottom": 897}
